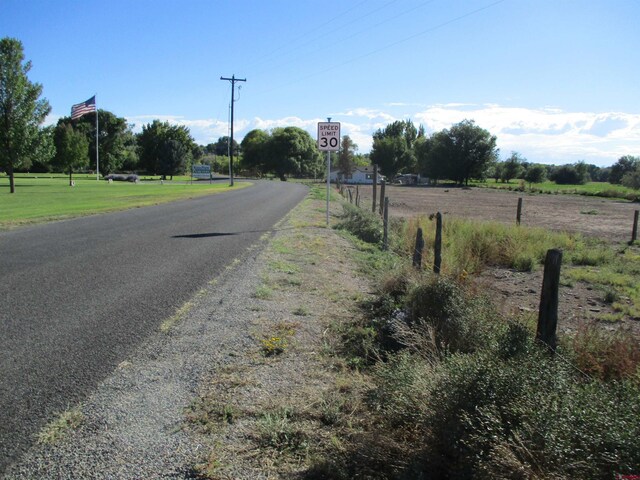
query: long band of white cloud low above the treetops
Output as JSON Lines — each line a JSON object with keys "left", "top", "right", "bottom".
{"left": 127, "top": 103, "right": 640, "bottom": 166}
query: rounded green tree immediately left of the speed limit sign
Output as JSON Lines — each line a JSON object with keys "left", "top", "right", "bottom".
{"left": 265, "top": 127, "right": 323, "bottom": 181}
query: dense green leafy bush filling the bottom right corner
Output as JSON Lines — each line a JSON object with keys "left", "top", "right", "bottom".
{"left": 425, "top": 350, "right": 640, "bottom": 479}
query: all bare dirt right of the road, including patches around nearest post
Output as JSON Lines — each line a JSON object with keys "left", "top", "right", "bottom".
{"left": 348, "top": 182, "right": 640, "bottom": 335}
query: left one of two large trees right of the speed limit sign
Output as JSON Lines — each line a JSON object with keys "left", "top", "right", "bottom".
{"left": 370, "top": 120, "right": 418, "bottom": 177}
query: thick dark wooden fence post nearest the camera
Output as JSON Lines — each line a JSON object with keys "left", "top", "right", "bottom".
{"left": 536, "top": 248, "right": 562, "bottom": 351}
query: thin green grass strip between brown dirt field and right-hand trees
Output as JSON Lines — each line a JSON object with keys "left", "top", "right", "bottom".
{"left": 472, "top": 179, "right": 640, "bottom": 200}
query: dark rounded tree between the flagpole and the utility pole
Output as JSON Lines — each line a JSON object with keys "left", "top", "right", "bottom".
{"left": 138, "top": 120, "right": 195, "bottom": 179}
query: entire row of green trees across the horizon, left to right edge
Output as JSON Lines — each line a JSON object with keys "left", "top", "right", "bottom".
{"left": 0, "top": 38, "right": 640, "bottom": 193}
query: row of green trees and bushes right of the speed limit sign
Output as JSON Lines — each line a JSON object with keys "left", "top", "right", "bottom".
{"left": 358, "top": 120, "right": 640, "bottom": 189}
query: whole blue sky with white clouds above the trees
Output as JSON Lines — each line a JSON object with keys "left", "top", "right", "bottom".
{"left": 0, "top": 0, "right": 640, "bottom": 166}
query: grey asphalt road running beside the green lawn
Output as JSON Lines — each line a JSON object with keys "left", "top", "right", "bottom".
{"left": 0, "top": 182, "right": 307, "bottom": 475}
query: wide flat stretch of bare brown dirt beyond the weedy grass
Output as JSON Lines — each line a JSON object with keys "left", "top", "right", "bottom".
{"left": 352, "top": 185, "right": 640, "bottom": 242}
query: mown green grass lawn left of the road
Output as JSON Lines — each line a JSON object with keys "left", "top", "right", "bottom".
{"left": 0, "top": 174, "right": 249, "bottom": 229}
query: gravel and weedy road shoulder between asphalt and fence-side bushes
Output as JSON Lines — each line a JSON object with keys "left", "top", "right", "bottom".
{"left": 4, "top": 189, "right": 367, "bottom": 479}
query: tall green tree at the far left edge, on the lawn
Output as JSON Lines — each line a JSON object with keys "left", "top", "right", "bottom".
{"left": 0, "top": 37, "right": 51, "bottom": 193}
